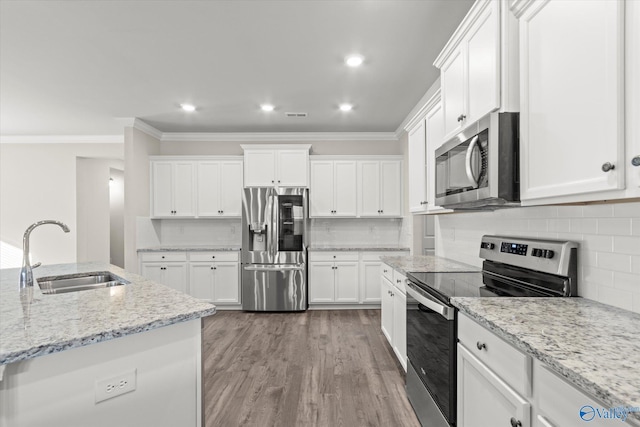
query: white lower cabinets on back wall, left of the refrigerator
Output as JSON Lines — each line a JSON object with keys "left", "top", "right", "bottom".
{"left": 140, "top": 251, "right": 241, "bottom": 305}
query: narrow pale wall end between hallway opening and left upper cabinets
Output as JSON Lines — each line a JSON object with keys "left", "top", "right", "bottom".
{"left": 124, "top": 127, "right": 160, "bottom": 273}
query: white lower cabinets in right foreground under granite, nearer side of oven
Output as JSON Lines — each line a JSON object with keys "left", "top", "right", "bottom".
{"left": 457, "top": 313, "right": 639, "bottom": 427}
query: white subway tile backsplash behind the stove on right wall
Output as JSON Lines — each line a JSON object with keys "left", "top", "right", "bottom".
{"left": 436, "top": 202, "right": 640, "bottom": 313}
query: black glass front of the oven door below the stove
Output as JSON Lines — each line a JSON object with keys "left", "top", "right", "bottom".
{"left": 407, "top": 295, "right": 456, "bottom": 423}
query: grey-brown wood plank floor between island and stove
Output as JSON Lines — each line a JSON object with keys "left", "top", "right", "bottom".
{"left": 203, "top": 310, "right": 420, "bottom": 427}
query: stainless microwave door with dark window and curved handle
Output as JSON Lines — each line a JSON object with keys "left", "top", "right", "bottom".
{"left": 436, "top": 129, "right": 489, "bottom": 197}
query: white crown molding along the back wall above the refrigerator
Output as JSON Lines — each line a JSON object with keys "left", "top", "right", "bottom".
{"left": 161, "top": 132, "right": 398, "bottom": 142}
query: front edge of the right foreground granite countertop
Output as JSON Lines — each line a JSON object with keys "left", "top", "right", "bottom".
{"left": 451, "top": 297, "right": 640, "bottom": 420}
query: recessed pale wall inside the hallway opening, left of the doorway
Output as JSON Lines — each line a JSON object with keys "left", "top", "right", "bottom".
{"left": 76, "top": 157, "right": 123, "bottom": 263}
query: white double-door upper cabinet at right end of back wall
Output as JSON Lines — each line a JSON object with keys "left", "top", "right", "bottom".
{"left": 358, "top": 160, "right": 402, "bottom": 218}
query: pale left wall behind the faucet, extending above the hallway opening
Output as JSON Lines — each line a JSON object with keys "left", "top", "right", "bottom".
{"left": 0, "top": 143, "right": 123, "bottom": 268}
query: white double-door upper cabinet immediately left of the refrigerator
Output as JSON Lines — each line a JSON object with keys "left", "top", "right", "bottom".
{"left": 196, "top": 160, "right": 242, "bottom": 217}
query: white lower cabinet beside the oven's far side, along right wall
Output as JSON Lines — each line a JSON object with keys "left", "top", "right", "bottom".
{"left": 379, "top": 264, "right": 407, "bottom": 372}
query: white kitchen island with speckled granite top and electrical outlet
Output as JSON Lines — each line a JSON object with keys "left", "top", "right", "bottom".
{"left": 0, "top": 263, "right": 215, "bottom": 426}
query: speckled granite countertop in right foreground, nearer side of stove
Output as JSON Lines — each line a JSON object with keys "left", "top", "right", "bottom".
{"left": 451, "top": 297, "right": 640, "bottom": 420}
